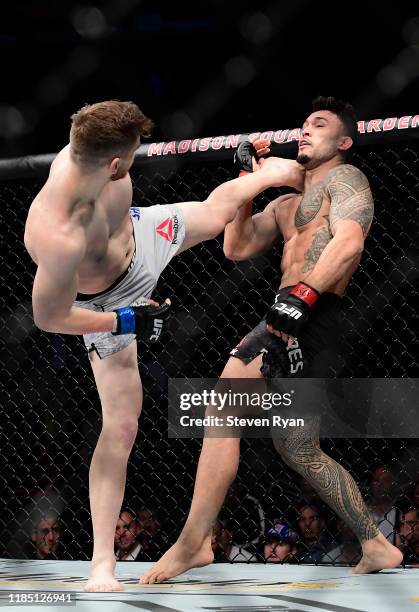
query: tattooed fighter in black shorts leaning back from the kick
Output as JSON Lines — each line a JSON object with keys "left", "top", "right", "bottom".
{"left": 141, "top": 97, "right": 402, "bottom": 583}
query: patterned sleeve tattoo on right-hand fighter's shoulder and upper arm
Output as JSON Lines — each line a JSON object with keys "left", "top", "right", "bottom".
{"left": 326, "top": 164, "right": 374, "bottom": 237}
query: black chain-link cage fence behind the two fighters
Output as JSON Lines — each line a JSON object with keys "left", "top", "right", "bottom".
{"left": 0, "top": 117, "right": 419, "bottom": 563}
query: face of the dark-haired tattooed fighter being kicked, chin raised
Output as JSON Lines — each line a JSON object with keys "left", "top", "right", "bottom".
{"left": 297, "top": 110, "right": 347, "bottom": 170}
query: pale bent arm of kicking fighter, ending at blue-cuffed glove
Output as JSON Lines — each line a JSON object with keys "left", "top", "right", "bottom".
{"left": 32, "top": 236, "right": 115, "bottom": 335}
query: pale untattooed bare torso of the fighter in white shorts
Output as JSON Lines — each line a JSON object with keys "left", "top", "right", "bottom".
{"left": 25, "top": 147, "right": 135, "bottom": 293}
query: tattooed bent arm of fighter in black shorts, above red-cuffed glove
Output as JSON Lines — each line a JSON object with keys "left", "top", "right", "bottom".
{"left": 303, "top": 165, "right": 374, "bottom": 293}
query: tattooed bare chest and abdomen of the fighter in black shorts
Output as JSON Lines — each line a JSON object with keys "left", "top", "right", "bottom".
{"left": 275, "top": 177, "right": 359, "bottom": 295}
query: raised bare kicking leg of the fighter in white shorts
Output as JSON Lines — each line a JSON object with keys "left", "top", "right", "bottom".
{"left": 178, "top": 163, "right": 294, "bottom": 253}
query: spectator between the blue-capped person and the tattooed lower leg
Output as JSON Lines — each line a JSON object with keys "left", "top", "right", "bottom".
{"left": 297, "top": 504, "right": 330, "bottom": 563}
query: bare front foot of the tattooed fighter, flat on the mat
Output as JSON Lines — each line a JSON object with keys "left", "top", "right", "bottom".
{"left": 140, "top": 537, "right": 214, "bottom": 584}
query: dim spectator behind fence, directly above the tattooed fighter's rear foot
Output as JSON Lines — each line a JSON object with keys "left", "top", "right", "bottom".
{"left": 367, "top": 465, "right": 397, "bottom": 544}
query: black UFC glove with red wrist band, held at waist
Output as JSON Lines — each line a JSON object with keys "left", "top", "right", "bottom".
{"left": 266, "top": 282, "right": 320, "bottom": 338}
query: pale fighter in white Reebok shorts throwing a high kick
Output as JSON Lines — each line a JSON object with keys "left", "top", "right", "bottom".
{"left": 24, "top": 100, "right": 304, "bottom": 591}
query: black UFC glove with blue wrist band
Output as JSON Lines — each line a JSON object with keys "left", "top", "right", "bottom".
{"left": 112, "top": 303, "right": 170, "bottom": 342}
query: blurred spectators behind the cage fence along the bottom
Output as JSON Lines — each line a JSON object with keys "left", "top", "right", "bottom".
{"left": 3, "top": 464, "right": 419, "bottom": 565}
